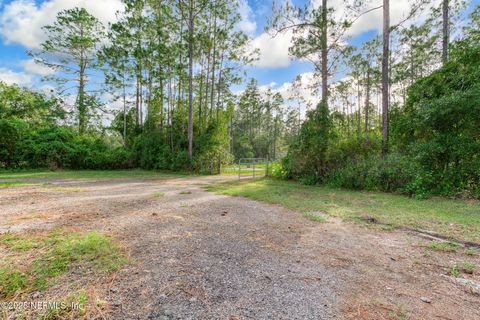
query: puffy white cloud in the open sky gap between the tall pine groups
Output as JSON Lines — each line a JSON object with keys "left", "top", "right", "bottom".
{"left": 250, "top": 31, "right": 292, "bottom": 68}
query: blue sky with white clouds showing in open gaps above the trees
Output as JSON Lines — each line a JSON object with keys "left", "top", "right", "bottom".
{"left": 0, "top": 0, "right": 480, "bottom": 108}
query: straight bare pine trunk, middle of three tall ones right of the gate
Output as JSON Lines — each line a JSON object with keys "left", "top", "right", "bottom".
{"left": 382, "top": 0, "right": 390, "bottom": 157}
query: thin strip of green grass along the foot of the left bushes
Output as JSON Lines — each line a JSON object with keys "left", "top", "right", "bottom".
{"left": 0, "top": 169, "right": 189, "bottom": 180}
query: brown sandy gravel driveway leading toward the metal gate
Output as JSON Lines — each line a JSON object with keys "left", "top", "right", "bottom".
{"left": 0, "top": 177, "right": 480, "bottom": 320}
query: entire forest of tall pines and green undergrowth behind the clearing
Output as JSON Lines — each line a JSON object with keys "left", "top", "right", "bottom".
{"left": 0, "top": 0, "right": 480, "bottom": 198}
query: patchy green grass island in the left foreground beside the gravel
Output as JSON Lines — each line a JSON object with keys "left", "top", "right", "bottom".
{"left": 0, "top": 230, "right": 127, "bottom": 298}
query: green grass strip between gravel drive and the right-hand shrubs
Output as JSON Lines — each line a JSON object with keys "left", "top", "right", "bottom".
{"left": 207, "top": 179, "right": 480, "bottom": 242}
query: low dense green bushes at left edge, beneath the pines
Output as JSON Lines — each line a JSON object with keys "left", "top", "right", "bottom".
{"left": 0, "top": 120, "right": 134, "bottom": 169}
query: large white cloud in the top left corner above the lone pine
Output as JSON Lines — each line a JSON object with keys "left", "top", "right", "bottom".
{"left": 0, "top": 0, "right": 123, "bottom": 49}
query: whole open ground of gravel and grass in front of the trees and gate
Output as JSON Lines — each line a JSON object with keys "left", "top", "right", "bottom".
{"left": 0, "top": 171, "right": 480, "bottom": 320}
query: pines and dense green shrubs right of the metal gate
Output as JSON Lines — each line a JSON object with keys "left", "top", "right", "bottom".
{"left": 271, "top": 0, "right": 480, "bottom": 197}
